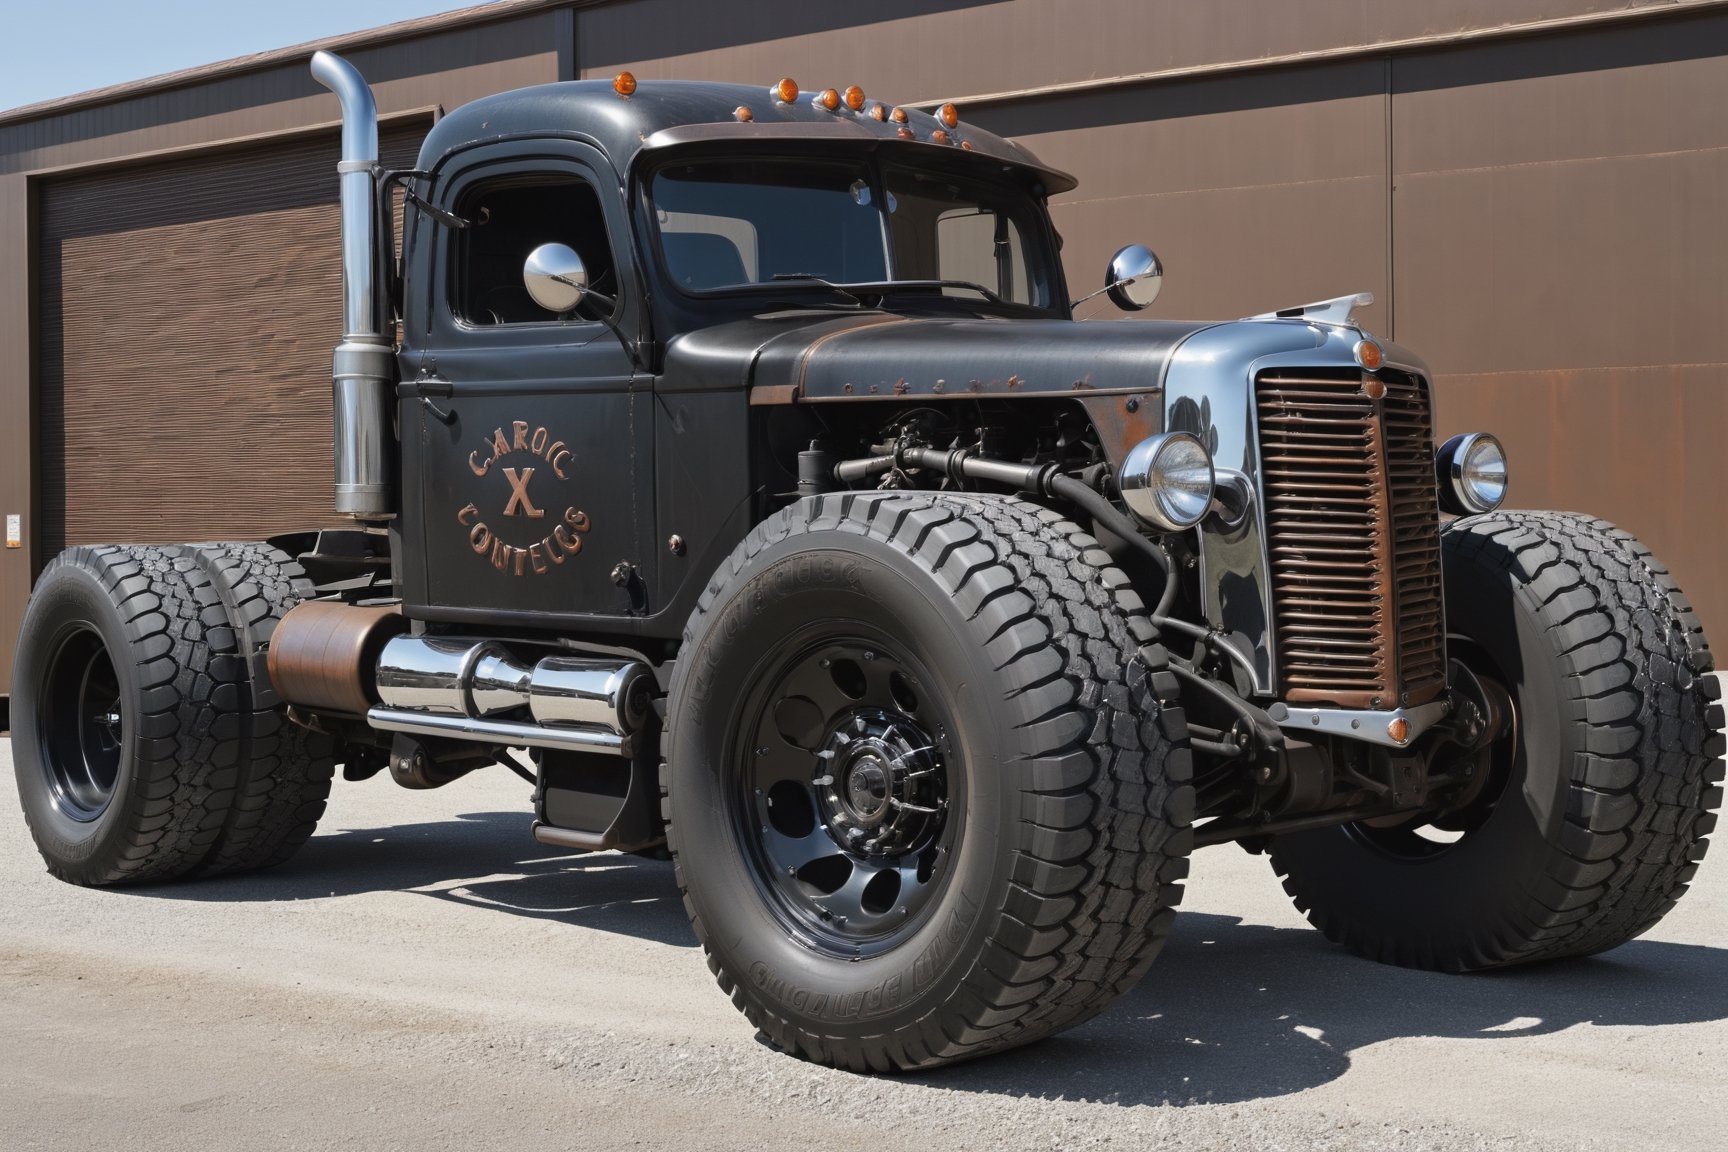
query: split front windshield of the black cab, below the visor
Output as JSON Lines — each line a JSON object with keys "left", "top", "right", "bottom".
{"left": 650, "top": 159, "right": 1054, "bottom": 307}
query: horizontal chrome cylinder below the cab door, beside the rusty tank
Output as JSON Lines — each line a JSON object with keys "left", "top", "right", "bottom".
{"left": 375, "top": 636, "right": 653, "bottom": 736}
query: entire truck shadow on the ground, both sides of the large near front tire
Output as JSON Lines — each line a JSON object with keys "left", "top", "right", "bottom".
{"left": 138, "top": 812, "right": 1728, "bottom": 1105}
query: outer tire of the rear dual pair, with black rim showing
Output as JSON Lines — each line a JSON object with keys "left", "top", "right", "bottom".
{"left": 12, "top": 546, "right": 240, "bottom": 884}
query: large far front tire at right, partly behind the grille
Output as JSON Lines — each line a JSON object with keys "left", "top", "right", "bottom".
{"left": 1272, "top": 511, "right": 1723, "bottom": 971}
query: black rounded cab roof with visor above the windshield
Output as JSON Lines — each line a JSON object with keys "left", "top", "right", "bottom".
{"left": 420, "top": 78, "right": 1078, "bottom": 195}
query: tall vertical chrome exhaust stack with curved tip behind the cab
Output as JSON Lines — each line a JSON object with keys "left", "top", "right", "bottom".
{"left": 313, "top": 52, "right": 396, "bottom": 520}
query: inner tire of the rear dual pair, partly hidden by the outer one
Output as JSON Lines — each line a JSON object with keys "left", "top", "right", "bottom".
{"left": 188, "top": 542, "right": 335, "bottom": 874}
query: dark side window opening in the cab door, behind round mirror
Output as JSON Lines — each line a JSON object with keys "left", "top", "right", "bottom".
{"left": 451, "top": 176, "right": 619, "bottom": 326}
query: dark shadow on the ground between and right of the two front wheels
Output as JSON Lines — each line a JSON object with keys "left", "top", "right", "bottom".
{"left": 921, "top": 912, "right": 1728, "bottom": 1105}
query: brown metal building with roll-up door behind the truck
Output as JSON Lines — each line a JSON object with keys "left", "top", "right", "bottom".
{"left": 0, "top": 0, "right": 1728, "bottom": 694}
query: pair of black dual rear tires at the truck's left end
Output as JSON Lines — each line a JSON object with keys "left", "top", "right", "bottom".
{"left": 12, "top": 544, "right": 334, "bottom": 884}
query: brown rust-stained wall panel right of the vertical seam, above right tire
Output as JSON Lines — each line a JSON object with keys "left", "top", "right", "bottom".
{"left": 1393, "top": 16, "right": 1728, "bottom": 630}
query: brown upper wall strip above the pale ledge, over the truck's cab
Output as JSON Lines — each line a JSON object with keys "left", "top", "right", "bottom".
{"left": 577, "top": 0, "right": 1707, "bottom": 102}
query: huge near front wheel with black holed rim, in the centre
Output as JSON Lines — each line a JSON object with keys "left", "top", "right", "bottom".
{"left": 664, "top": 494, "right": 1194, "bottom": 1071}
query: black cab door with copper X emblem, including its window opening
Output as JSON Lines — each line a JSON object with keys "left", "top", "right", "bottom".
{"left": 401, "top": 142, "right": 657, "bottom": 625}
